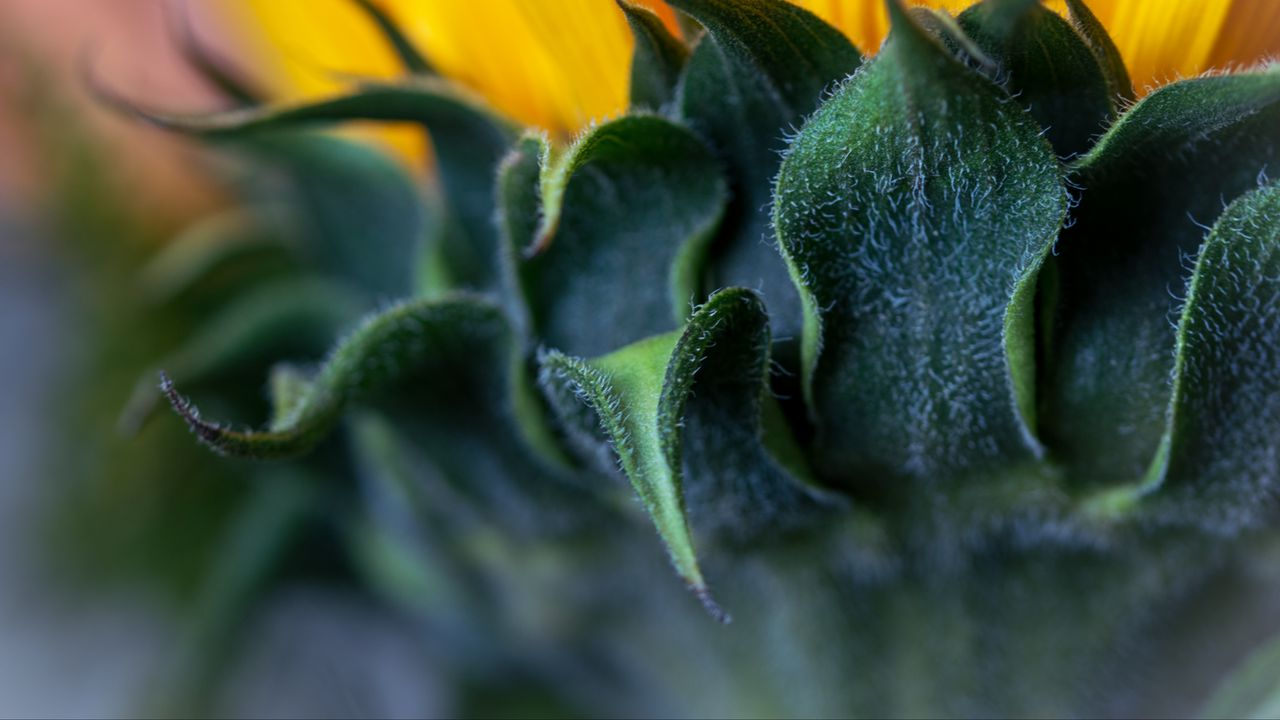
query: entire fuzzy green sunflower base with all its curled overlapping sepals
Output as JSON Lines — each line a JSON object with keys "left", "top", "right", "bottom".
{"left": 94, "top": 0, "right": 1280, "bottom": 716}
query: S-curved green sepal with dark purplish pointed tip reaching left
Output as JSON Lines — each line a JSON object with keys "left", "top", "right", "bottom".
{"left": 160, "top": 297, "right": 507, "bottom": 459}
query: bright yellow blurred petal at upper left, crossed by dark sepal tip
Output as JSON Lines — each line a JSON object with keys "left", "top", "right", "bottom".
{"left": 224, "top": 0, "right": 673, "bottom": 133}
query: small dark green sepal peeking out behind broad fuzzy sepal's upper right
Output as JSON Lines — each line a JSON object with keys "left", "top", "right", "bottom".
{"left": 959, "top": 0, "right": 1115, "bottom": 158}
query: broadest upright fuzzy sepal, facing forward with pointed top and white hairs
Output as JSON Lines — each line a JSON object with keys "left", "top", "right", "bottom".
{"left": 774, "top": 3, "right": 1066, "bottom": 483}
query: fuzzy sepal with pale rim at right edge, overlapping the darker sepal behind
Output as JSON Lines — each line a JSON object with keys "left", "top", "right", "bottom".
{"left": 1085, "top": 184, "right": 1280, "bottom": 533}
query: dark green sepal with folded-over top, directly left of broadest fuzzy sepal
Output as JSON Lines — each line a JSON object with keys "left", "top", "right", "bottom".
{"left": 669, "top": 0, "right": 861, "bottom": 341}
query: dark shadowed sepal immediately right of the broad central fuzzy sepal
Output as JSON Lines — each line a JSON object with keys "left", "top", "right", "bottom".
{"left": 1041, "top": 67, "right": 1280, "bottom": 486}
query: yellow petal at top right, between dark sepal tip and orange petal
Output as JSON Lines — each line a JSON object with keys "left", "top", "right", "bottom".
{"left": 1088, "top": 0, "right": 1231, "bottom": 94}
